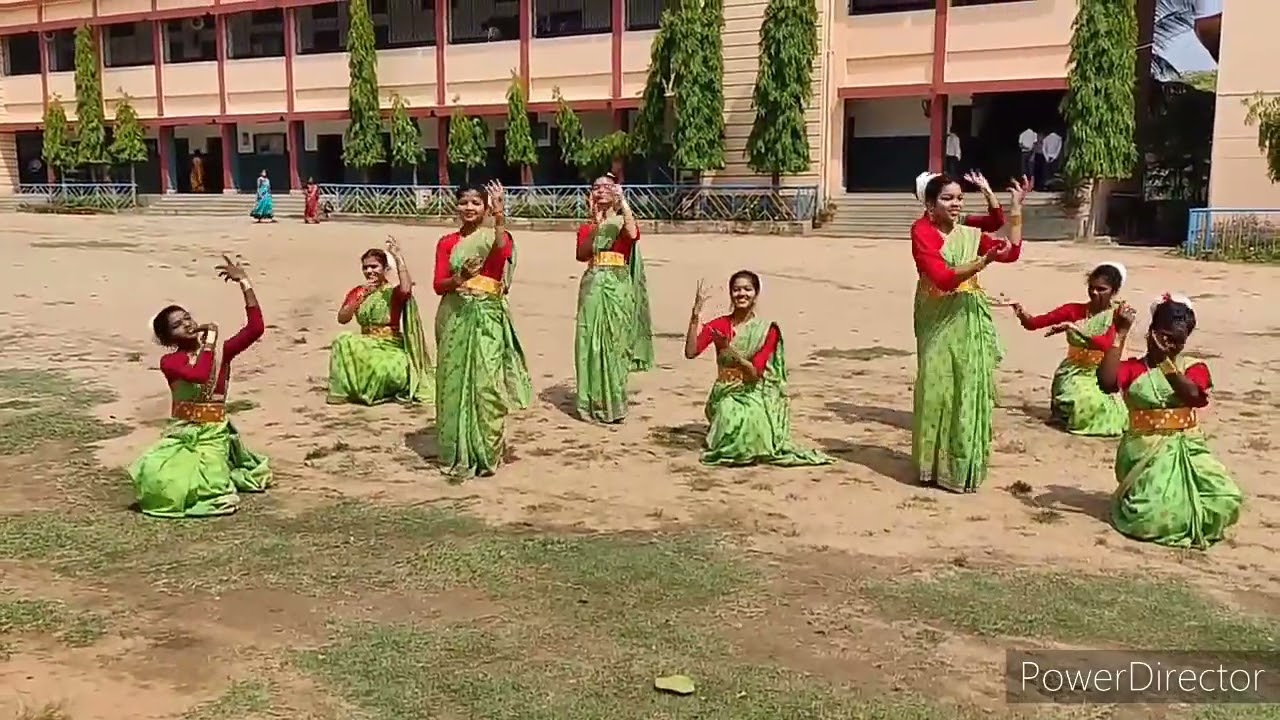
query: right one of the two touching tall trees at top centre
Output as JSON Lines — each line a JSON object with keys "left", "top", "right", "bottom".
{"left": 671, "top": 0, "right": 724, "bottom": 172}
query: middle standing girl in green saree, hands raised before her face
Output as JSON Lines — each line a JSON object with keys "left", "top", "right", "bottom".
{"left": 573, "top": 176, "right": 653, "bottom": 423}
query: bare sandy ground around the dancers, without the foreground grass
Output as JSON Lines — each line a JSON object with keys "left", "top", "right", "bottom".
{"left": 0, "top": 215, "right": 1280, "bottom": 717}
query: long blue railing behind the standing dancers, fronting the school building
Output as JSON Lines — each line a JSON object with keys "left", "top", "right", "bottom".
{"left": 320, "top": 184, "right": 818, "bottom": 222}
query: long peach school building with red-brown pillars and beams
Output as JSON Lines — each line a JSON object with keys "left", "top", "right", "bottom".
{"left": 0, "top": 0, "right": 1276, "bottom": 206}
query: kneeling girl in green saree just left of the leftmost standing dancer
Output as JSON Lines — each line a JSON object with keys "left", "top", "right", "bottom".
{"left": 329, "top": 238, "right": 435, "bottom": 405}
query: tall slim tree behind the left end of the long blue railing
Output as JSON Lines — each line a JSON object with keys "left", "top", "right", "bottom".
{"left": 342, "top": 0, "right": 387, "bottom": 182}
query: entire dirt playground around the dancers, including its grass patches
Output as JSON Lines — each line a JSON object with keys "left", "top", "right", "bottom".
{"left": 0, "top": 215, "right": 1280, "bottom": 720}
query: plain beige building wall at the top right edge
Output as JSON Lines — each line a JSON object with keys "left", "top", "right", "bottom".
{"left": 1208, "top": 0, "right": 1280, "bottom": 210}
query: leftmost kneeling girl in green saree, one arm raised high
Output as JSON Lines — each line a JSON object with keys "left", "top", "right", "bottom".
{"left": 128, "top": 255, "right": 271, "bottom": 518}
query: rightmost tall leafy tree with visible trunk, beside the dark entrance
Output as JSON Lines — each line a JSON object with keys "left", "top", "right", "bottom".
{"left": 1061, "top": 0, "right": 1138, "bottom": 236}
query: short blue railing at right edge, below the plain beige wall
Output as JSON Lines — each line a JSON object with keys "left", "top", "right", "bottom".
{"left": 1183, "top": 208, "right": 1280, "bottom": 263}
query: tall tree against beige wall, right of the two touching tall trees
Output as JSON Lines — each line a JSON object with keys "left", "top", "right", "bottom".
{"left": 746, "top": 0, "right": 818, "bottom": 188}
